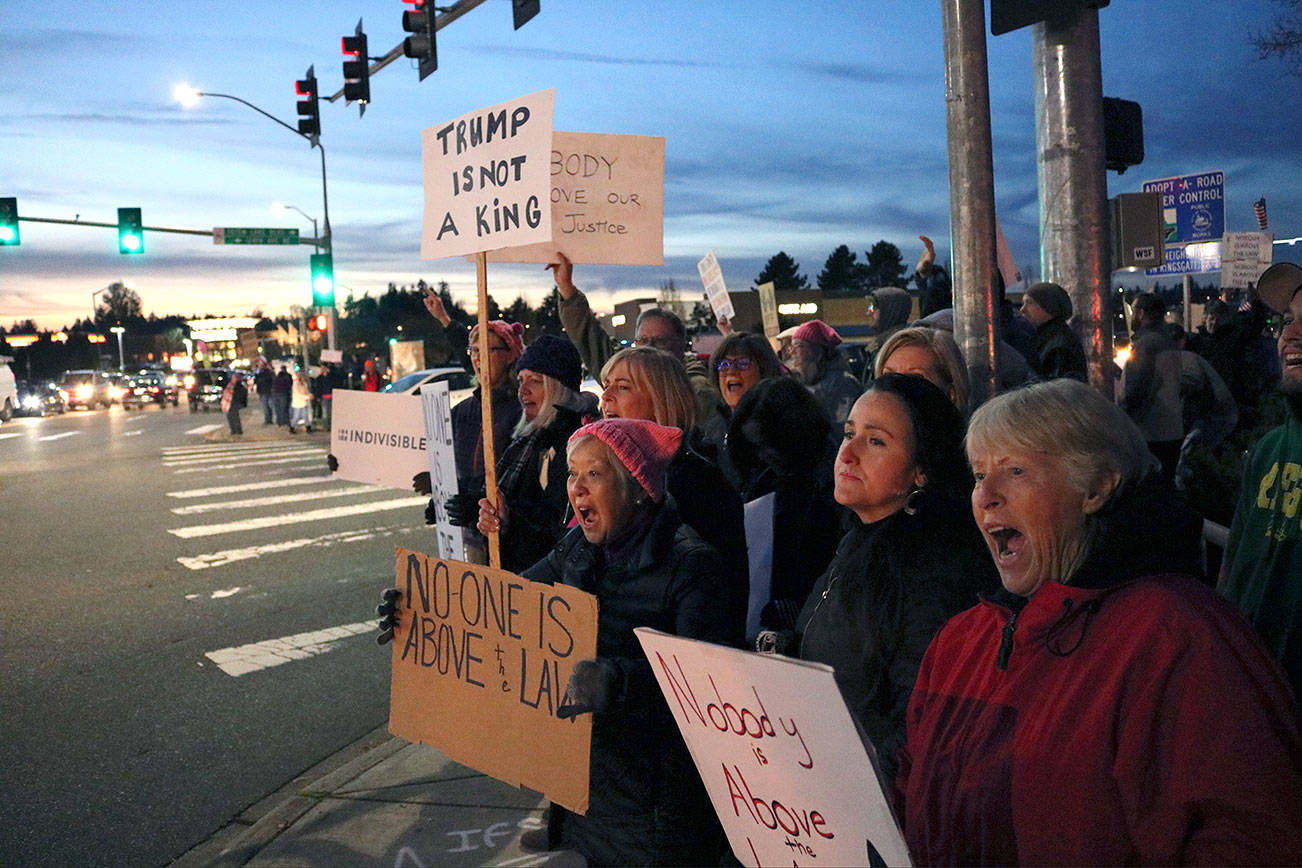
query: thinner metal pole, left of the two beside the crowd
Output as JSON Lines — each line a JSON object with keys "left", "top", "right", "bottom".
{"left": 941, "top": 0, "right": 1001, "bottom": 407}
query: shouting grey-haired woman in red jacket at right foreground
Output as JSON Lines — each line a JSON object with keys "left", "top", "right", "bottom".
{"left": 897, "top": 379, "right": 1302, "bottom": 865}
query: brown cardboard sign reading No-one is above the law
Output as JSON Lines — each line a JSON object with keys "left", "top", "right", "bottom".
{"left": 389, "top": 548, "right": 596, "bottom": 813}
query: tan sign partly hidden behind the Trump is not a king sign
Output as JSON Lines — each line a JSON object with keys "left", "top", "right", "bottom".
{"left": 488, "top": 130, "right": 664, "bottom": 265}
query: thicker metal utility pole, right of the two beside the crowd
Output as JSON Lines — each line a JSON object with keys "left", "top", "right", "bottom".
{"left": 1031, "top": 7, "right": 1113, "bottom": 397}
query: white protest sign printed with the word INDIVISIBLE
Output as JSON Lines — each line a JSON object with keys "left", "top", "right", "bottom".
{"left": 329, "top": 389, "right": 430, "bottom": 491}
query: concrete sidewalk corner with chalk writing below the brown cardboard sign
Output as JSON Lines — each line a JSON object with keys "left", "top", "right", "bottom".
{"left": 172, "top": 726, "right": 585, "bottom": 868}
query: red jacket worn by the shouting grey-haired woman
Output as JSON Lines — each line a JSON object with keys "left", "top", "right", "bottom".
{"left": 898, "top": 575, "right": 1302, "bottom": 865}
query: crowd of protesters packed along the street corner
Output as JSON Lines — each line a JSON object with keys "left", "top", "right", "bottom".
{"left": 369, "top": 243, "right": 1302, "bottom": 865}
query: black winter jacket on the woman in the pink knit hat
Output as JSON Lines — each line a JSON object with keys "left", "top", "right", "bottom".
{"left": 523, "top": 498, "right": 746, "bottom": 865}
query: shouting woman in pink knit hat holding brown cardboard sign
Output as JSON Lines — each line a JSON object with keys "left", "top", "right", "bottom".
{"left": 523, "top": 419, "right": 746, "bottom": 865}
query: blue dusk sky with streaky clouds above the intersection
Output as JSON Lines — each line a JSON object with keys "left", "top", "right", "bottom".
{"left": 0, "top": 0, "right": 1302, "bottom": 328}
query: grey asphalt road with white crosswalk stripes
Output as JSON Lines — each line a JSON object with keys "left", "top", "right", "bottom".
{"left": 0, "top": 401, "right": 432, "bottom": 868}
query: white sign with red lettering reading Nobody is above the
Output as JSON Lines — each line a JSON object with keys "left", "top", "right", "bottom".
{"left": 635, "top": 627, "right": 910, "bottom": 865}
